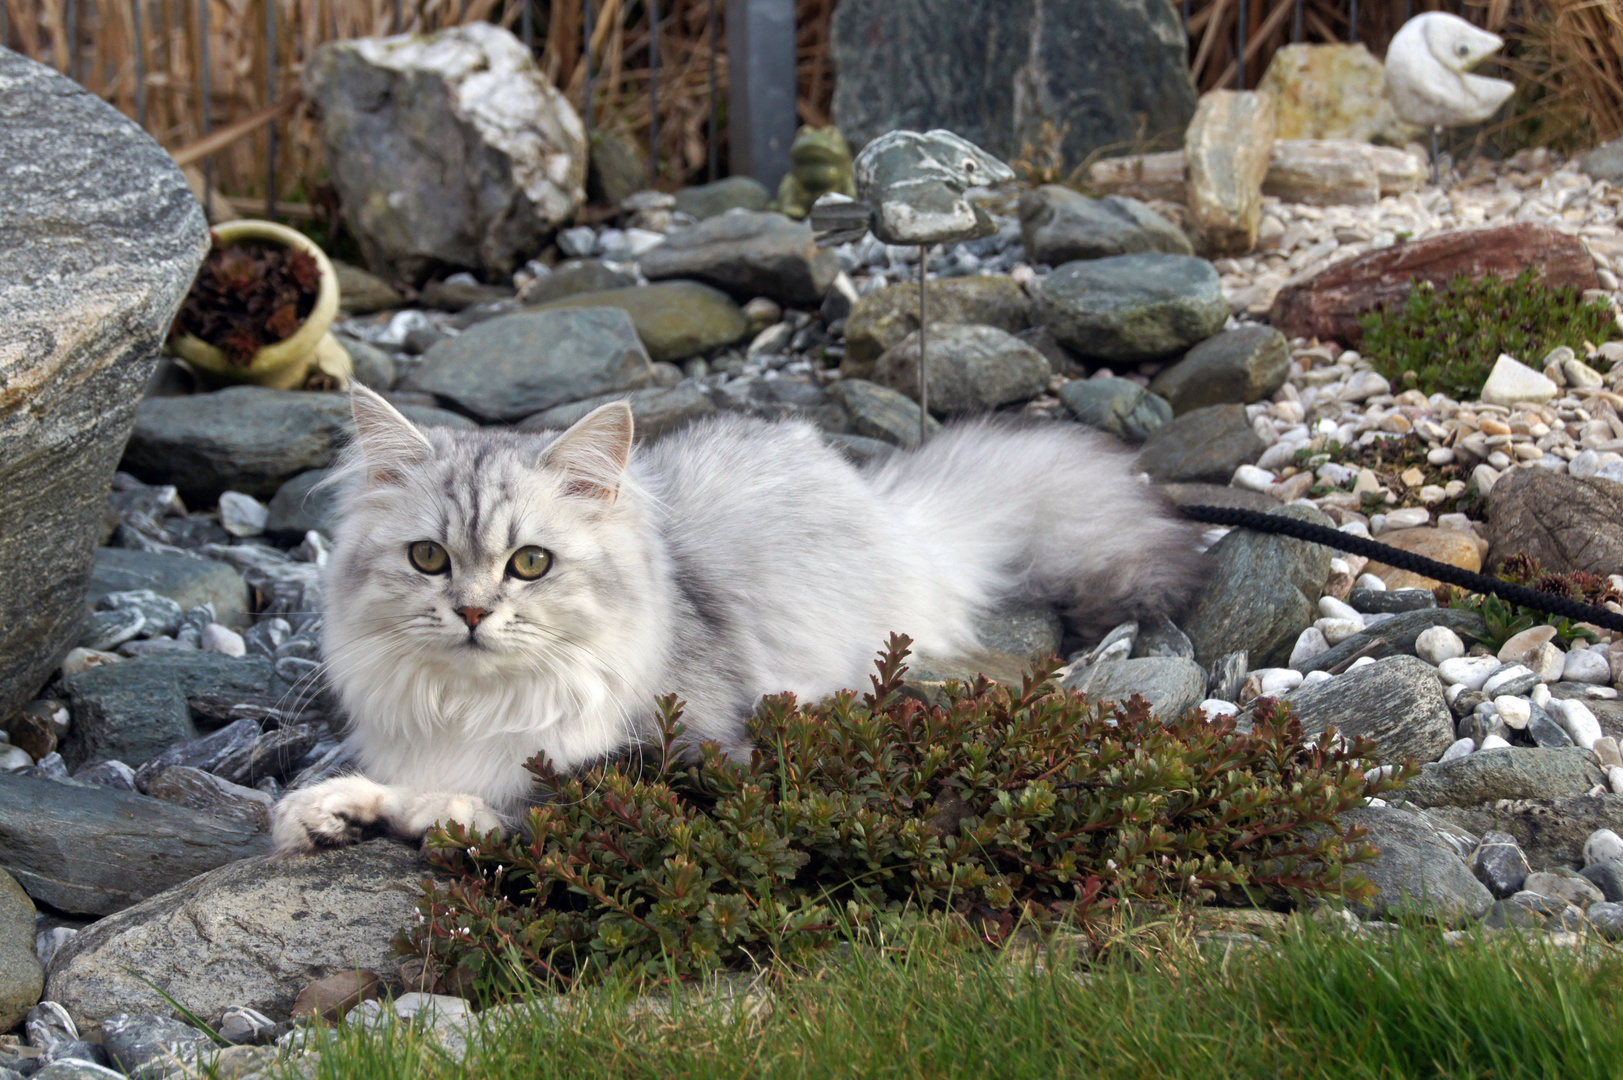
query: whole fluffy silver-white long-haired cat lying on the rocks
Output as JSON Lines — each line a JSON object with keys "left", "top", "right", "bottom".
{"left": 274, "top": 387, "right": 1201, "bottom": 853}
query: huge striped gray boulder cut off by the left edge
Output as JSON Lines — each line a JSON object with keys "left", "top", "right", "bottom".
{"left": 0, "top": 49, "right": 208, "bottom": 719}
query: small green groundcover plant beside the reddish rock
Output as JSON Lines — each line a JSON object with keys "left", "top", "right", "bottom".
{"left": 1360, "top": 270, "right": 1618, "bottom": 401}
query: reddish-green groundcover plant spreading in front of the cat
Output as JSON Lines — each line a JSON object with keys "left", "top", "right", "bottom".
{"left": 396, "top": 637, "right": 1383, "bottom": 992}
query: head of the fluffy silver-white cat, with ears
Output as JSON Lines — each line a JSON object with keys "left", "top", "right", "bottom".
{"left": 326, "top": 387, "right": 646, "bottom": 682}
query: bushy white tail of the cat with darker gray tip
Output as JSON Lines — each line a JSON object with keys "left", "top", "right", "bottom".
{"left": 865, "top": 417, "right": 1206, "bottom": 638}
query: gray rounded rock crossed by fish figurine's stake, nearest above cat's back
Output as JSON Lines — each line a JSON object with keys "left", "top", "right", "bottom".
{"left": 873, "top": 323, "right": 1053, "bottom": 416}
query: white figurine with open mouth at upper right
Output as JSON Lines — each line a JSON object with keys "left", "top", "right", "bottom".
{"left": 1386, "top": 11, "right": 1516, "bottom": 128}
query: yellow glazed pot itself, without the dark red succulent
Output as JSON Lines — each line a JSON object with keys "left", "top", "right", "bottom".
{"left": 169, "top": 219, "right": 354, "bottom": 390}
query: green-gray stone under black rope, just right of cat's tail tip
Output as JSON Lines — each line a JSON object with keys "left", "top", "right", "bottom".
{"left": 1183, "top": 505, "right": 1332, "bottom": 667}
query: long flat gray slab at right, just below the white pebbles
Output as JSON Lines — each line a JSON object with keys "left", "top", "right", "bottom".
{"left": 1396, "top": 747, "right": 1607, "bottom": 806}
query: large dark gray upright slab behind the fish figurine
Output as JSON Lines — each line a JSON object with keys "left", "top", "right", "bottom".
{"left": 831, "top": 0, "right": 1196, "bottom": 164}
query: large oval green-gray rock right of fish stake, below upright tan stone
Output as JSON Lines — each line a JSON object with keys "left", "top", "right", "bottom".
{"left": 1037, "top": 253, "right": 1229, "bottom": 362}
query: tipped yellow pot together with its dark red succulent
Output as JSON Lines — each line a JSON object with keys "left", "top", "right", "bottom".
{"left": 169, "top": 221, "right": 352, "bottom": 390}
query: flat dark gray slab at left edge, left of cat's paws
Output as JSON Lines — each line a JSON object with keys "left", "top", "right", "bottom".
{"left": 0, "top": 773, "right": 271, "bottom": 915}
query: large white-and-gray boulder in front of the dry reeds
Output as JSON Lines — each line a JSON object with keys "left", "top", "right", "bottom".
{"left": 304, "top": 23, "right": 586, "bottom": 284}
